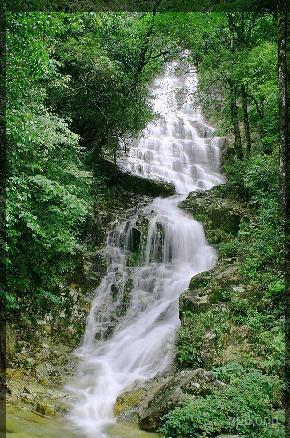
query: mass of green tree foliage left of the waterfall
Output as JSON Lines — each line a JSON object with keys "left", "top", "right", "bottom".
{"left": 6, "top": 12, "right": 175, "bottom": 318}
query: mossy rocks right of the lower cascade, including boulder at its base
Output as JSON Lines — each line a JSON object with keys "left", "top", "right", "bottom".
{"left": 115, "top": 186, "right": 251, "bottom": 431}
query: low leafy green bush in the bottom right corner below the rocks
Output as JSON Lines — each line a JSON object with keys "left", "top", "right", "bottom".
{"left": 161, "top": 364, "right": 284, "bottom": 438}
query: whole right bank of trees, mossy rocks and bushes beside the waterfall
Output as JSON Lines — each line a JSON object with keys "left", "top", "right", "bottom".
{"left": 157, "top": 10, "right": 285, "bottom": 437}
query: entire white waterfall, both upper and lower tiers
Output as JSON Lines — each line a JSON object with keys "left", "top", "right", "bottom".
{"left": 69, "top": 58, "right": 224, "bottom": 438}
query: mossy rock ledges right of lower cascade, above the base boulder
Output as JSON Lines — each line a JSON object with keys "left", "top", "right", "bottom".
{"left": 176, "top": 186, "right": 253, "bottom": 370}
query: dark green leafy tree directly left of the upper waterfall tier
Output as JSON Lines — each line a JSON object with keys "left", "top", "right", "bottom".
{"left": 49, "top": 13, "right": 176, "bottom": 166}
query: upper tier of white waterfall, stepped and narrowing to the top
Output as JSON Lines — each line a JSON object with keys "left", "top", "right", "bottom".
{"left": 118, "top": 61, "right": 224, "bottom": 193}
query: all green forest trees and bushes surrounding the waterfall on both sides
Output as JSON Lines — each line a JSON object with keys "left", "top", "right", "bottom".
{"left": 6, "top": 11, "right": 284, "bottom": 437}
